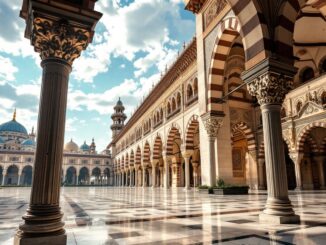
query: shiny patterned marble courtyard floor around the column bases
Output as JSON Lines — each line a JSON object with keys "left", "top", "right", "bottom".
{"left": 0, "top": 187, "right": 326, "bottom": 245}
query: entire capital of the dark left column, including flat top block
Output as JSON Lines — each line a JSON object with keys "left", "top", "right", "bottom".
{"left": 20, "top": 1, "right": 102, "bottom": 65}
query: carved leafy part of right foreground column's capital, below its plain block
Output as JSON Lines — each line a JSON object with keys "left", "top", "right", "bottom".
{"left": 247, "top": 72, "right": 293, "bottom": 105}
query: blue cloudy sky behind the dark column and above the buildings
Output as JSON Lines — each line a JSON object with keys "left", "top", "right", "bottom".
{"left": 0, "top": 0, "right": 195, "bottom": 151}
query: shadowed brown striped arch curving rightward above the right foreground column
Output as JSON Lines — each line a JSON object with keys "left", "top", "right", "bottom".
{"left": 275, "top": 0, "right": 307, "bottom": 59}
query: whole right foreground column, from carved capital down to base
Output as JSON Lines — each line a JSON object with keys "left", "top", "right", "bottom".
{"left": 244, "top": 59, "right": 300, "bottom": 224}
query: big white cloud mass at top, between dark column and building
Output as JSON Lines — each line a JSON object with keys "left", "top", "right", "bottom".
{"left": 72, "top": 0, "right": 195, "bottom": 83}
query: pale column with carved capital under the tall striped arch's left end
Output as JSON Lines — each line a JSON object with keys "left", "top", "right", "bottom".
{"left": 201, "top": 113, "right": 223, "bottom": 186}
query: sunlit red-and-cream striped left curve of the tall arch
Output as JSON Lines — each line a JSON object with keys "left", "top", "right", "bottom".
{"left": 208, "top": 17, "right": 240, "bottom": 111}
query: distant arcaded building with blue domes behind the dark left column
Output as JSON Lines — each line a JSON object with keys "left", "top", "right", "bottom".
{"left": 0, "top": 112, "right": 113, "bottom": 186}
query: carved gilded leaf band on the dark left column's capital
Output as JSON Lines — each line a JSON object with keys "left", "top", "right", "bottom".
{"left": 31, "top": 17, "right": 90, "bottom": 64}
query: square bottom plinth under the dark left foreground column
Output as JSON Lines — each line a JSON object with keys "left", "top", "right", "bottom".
{"left": 14, "top": 234, "right": 67, "bottom": 245}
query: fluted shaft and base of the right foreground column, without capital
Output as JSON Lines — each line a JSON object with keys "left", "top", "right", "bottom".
{"left": 260, "top": 104, "right": 299, "bottom": 223}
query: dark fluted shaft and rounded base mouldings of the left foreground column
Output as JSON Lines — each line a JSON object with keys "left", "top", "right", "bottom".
{"left": 19, "top": 58, "right": 71, "bottom": 236}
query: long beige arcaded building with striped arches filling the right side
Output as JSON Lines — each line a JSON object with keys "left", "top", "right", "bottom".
{"left": 108, "top": 0, "right": 326, "bottom": 193}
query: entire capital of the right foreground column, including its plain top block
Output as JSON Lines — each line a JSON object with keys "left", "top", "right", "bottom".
{"left": 242, "top": 57, "right": 297, "bottom": 105}
